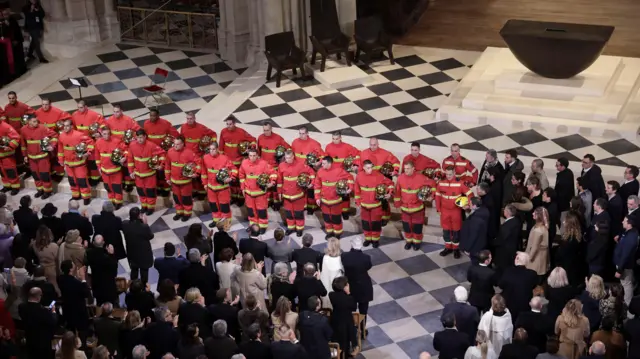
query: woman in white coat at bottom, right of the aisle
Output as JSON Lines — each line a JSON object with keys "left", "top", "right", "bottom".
{"left": 478, "top": 294, "right": 513, "bottom": 355}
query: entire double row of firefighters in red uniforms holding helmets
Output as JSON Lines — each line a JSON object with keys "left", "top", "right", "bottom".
{"left": 0, "top": 93, "right": 478, "bottom": 256}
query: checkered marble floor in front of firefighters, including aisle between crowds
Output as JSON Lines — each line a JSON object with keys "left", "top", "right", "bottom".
{"left": 9, "top": 190, "right": 469, "bottom": 359}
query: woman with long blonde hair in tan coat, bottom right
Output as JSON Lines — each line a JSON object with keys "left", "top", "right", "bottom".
{"left": 555, "top": 299, "right": 590, "bottom": 359}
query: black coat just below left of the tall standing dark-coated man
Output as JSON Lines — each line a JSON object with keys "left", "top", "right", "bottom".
{"left": 85, "top": 247, "right": 118, "bottom": 305}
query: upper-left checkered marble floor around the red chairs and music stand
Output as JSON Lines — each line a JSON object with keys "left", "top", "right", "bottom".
{"left": 25, "top": 44, "right": 246, "bottom": 125}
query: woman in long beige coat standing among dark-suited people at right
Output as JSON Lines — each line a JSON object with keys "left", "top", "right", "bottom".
{"left": 525, "top": 207, "right": 549, "bottom": 278}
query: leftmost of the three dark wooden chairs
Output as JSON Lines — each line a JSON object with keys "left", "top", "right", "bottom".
{"left": 264, "top": 31, "right": 307, "bottom": 87}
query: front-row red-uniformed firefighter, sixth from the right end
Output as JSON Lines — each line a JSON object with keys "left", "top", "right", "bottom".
{"left": 238, "top": 148, "right": 278, "bottom": 234}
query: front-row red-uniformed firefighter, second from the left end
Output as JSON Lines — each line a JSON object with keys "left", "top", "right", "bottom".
{"left": 20, "top": 116, "right": 58, "bottom": 199}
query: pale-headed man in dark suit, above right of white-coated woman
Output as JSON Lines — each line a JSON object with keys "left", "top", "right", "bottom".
{"left": 498, "top": 252, "right": 538, "bottom": 323}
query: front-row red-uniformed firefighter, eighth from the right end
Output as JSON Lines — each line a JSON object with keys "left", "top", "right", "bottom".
{"left": 164, "top": 136, "right": 200, "bottom": 222}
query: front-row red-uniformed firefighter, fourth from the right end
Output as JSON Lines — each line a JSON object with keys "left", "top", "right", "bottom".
{"left": 313, "top": 156, "right": 353, "bottom": 239}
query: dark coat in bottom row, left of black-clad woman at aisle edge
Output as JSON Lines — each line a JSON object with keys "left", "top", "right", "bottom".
{"left": 298, "top": 310, "right": 333, "bottom": 359}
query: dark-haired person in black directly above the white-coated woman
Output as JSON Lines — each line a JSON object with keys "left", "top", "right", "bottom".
{"left": 467, "top": 249, "right": 498, "bottom": 316}
